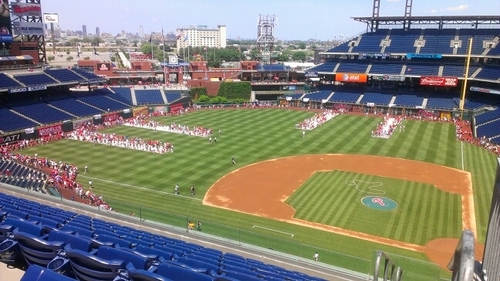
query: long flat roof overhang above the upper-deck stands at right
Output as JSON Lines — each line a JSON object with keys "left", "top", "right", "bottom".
{"left": 352, "top": 15, "right": 500, "bottom": 31}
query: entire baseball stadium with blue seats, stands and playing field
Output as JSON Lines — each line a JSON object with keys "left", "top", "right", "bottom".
{"left": 0, "top": 0, "right": 500, "bottom": 281}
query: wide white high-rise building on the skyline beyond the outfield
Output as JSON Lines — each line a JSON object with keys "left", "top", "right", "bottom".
{"left": 176, "top": 25, "right": 227, "bottom": 49}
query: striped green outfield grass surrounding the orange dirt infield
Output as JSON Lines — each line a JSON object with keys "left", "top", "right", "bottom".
{"left": 23, "top": 109, "right": 495, "bottom": 272}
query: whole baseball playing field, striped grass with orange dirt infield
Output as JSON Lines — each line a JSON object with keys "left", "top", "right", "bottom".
{"left": 23, "top": 109, "right": 495, "bottom": 280}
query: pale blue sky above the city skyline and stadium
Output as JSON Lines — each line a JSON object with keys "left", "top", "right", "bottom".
{"left": 42, "top": 0, "right": 500, "bottom": 40}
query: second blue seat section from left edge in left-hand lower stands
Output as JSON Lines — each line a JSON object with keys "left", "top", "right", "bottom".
{"left": 11, "top": 102, "right": 75, "bottom": 124}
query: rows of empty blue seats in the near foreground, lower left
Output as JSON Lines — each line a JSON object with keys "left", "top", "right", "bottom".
{"left": 0, "top": 193, "right": 324, "bottom": 281}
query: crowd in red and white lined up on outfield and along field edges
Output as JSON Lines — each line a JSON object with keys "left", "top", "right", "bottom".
{"left": 0, "top": 103, "right": 500, "bottom": 214}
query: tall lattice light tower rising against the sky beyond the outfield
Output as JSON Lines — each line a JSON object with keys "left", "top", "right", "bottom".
{"left": 257, "top": 15, "right": 278, "bottom": 63}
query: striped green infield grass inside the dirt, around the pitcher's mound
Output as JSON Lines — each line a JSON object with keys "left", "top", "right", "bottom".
{"left": 286, "top": 170, "right": 462, "bottom": 245}
